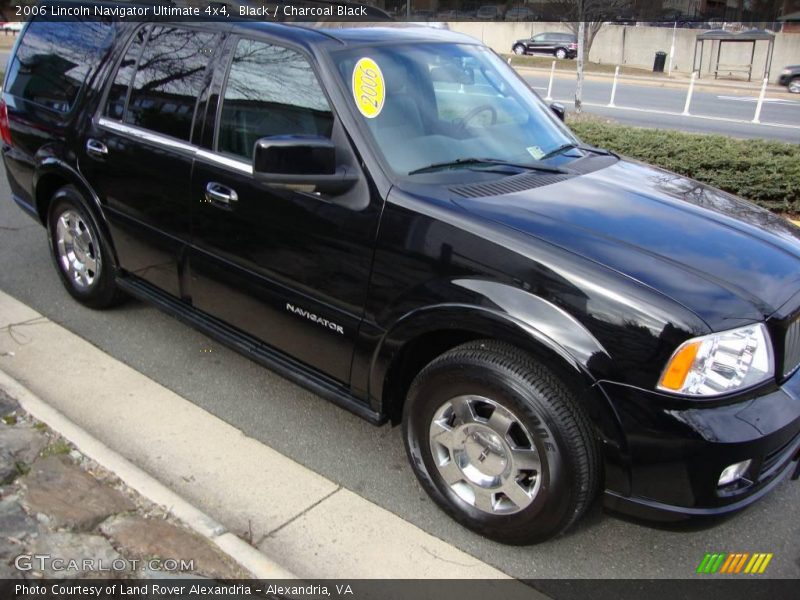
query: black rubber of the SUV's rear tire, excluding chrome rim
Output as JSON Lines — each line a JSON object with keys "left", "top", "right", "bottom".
{"left": 47, "top": 185, "right": 125, "bottom": 309}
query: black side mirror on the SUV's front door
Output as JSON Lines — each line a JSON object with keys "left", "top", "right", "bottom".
{"left": 253, "top": 135, "right": 358, "bottom": 194}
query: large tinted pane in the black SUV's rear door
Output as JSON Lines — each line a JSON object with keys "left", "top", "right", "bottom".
{"left": 125, "top": 26, "right": 214, "bottom": 140}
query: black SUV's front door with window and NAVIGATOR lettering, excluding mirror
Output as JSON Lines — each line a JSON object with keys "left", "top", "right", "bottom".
{"left": 190, "top": 38, "right": 381, "bottom": 383}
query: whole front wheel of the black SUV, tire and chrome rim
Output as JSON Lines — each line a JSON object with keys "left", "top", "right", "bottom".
{"left": 403, "top": 340, "right": 601, "bottom": 545}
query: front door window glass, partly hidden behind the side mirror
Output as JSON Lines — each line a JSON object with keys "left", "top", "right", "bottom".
{"left": 217, "top": 39, "right": 333, "bottom": 159}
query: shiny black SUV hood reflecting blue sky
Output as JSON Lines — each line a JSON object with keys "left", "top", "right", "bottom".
{"left": 454, "top": 160, "right": 800, "bottom": 329}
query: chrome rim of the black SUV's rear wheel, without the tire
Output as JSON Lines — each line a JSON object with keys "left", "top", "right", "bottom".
{"left": 56, "top": 210, "right": 101, "bottom": 290}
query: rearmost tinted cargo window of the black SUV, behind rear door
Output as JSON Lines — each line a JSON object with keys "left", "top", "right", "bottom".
{"left": 7, "top": 19, "right": 114, "bottom": 112}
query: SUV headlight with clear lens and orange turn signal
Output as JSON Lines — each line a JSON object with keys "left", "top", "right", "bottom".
{"left": 658, "top": 323, "right": 775, "bottom": 396}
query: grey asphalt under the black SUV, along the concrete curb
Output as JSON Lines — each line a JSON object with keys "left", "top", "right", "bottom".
{"left": 0, "top": 167, "right": 800, "bottom": 578}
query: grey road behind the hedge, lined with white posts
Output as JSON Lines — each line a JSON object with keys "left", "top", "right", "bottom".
{"left": 524, "top": 74, "right": 800, "bottom": 142}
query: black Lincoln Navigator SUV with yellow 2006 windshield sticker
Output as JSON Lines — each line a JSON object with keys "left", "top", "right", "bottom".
{"left": 0, "top": 9, "right": 800, "bottom": 544}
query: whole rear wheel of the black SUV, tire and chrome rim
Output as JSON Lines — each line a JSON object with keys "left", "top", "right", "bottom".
{"left": 47, "top": 185, "right": 124, "bottom": 309}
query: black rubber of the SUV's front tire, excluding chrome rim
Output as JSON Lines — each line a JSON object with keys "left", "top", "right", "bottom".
{"left": 403, "top": 340, "right": 601, "bottom": 545}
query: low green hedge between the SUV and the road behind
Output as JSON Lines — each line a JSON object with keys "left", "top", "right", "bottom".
{"left": 569, "top": 120, "right": 800, "bottom": 214}
